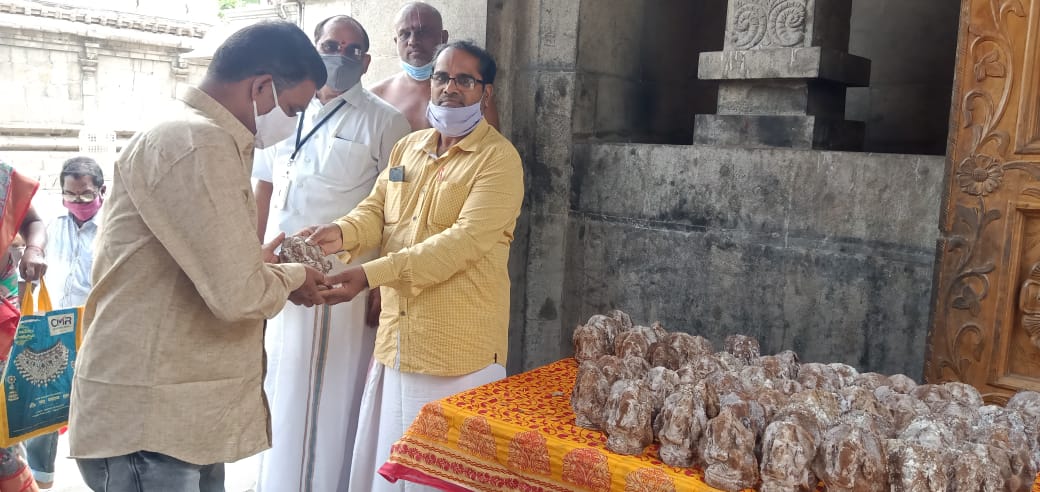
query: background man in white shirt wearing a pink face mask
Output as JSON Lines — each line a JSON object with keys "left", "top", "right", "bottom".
{"left": 25, "top": 157, "right": 105, "bottom": 489}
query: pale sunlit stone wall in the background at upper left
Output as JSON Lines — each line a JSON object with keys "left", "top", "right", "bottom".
{"left": 0, "top": 4, "right": 205, "bottom": 200}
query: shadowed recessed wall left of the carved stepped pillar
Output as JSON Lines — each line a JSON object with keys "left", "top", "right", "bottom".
{"left": 574, "top": 0, "right": 726, "bottom": 143}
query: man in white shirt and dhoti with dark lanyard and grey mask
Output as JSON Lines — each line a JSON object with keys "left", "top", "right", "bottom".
{"left": 253, "top": 16, "right": 411, "bottom": 492}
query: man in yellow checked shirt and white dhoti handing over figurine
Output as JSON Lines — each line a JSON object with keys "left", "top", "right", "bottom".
{"left": 301, "top": 42, "right": 523, "bottom": 491}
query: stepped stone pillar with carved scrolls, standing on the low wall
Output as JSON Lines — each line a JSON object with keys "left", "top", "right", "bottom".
{"left": 694, "top": 0, "right": 870, "bottom": 150}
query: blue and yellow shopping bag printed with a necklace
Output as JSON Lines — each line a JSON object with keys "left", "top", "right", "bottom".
{"left": 0, "top": 281, "right": 82, "bottom": 446}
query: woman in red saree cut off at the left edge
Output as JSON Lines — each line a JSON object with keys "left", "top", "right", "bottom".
{"left": 0, "top": 160, "right": 47, "bottom": 492}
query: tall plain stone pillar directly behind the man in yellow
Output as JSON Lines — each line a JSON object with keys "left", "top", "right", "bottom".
{"left": 487, "top": 0, "right": 582, "bottom": 373}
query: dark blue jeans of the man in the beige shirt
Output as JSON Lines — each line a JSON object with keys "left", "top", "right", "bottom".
{"left": 76, "top": 451, "right": 224, "bottom": 492}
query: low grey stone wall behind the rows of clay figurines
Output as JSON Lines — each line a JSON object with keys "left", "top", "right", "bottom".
{"left": 558, "top": 145, "right": 943, "bottom": 379}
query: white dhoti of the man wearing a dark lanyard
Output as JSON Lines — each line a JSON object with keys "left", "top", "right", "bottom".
{"left": 257, "top": 295, "right": 375, "bottom": 492}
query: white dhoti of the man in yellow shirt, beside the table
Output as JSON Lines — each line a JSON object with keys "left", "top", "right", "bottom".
{"left": 350, "top": 362, "right": 505, "bottom": 492}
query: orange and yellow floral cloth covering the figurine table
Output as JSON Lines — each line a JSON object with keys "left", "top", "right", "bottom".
{"left": 380, "top": 359, "right": 1040, "bottom": 492}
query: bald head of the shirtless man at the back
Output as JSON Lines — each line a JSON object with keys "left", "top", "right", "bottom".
{"left": 393, "top": 2, "right": 448, "bottom": 67}
